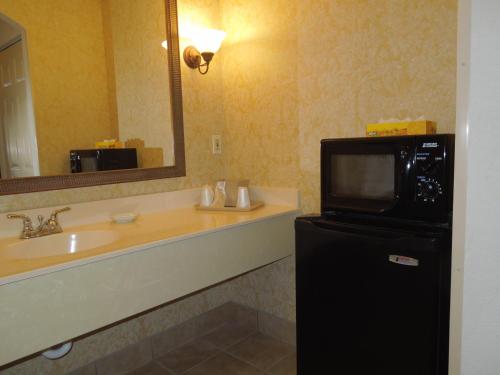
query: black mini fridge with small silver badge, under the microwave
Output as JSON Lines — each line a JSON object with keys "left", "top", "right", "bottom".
{"left": 295, "top": 218, "right": 450, "bottom": 375}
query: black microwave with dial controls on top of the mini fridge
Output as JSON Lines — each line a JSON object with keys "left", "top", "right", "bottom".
{"left": 321, "top": 134, "right": 454, "bottom": 222}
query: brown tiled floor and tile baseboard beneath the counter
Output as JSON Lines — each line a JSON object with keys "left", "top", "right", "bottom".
{"left": 66, "top": 302, "right": 295, "bottom": 375}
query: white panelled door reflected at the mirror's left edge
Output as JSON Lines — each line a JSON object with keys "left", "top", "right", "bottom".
{"left": 0, "top": 41, "right": 39, "bottom": 178}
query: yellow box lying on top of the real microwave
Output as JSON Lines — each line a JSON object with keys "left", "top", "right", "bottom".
{"left": 366, "top": 120, "right": 437, "bottom": 137}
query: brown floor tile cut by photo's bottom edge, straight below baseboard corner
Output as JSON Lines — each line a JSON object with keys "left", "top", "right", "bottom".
{"left": 184, "top": 353, "right": 264, "bottom": 375}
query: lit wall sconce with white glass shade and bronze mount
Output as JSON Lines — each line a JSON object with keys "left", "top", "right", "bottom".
{"left": 183, "top": 29, "right": 226, "bottom": 74}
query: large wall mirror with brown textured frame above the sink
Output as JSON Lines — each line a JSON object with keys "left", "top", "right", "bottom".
{"left": 0, "top": 0, "right": 185, "bottom": 194}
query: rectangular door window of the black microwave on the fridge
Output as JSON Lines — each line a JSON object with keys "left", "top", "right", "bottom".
{"left": 330, "top": 154, "right": 396, "bottom": 200}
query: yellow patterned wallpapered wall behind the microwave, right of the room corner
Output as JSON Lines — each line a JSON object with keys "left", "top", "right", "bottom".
{"left": 221, "top": 0, "right": 457, "bottom": 211}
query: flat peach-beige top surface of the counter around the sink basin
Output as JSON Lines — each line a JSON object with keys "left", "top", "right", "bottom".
{"left": 0, "top": 205, "right": 297, "bottom": 285}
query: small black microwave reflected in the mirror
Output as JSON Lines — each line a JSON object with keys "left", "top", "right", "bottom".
{"left": 69, "top": 148, "right": 137, "bottom": 173}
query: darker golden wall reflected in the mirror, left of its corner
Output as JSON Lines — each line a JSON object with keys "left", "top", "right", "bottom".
{"left": 0, "top": 0, "right": 116, "bottom": 175}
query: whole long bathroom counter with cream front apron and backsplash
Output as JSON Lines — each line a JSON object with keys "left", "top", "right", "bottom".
{"left": 0, "top": 188, "right": 300, "bottom": 366}
